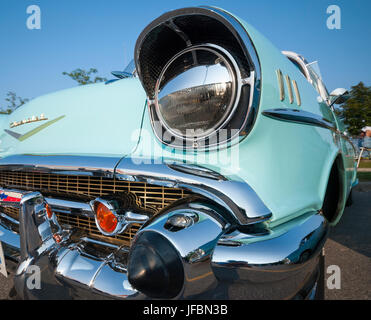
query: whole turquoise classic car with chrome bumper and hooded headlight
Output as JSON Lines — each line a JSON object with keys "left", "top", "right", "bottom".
{"left": 0, "top": 6, "right": 357, "bottom": 299}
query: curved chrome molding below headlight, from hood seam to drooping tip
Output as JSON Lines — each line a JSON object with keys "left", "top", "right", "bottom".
{"left": 116, "top": 158, "right": 272, "bottom": 225}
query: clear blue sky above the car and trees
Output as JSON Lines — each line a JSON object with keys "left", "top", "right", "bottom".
{"left": 0, "top": 0, "right": 371, "bottom": 107}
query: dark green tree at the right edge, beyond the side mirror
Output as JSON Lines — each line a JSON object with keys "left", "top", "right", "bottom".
{"left": 337, "top": 82, "right": 371, "bottom": 135}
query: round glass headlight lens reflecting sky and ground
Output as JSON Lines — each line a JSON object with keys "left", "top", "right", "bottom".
{"left": 155, "top": 45, "right": 239, "bottom": 139}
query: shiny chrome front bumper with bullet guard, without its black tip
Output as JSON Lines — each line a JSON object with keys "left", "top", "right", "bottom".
{"left": 1, "top": 192, "right": 328, "bottom": 299}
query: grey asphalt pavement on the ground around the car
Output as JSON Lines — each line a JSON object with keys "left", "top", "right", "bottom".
{"left": 0, "top": 188, "right": 371, "bottom": 300}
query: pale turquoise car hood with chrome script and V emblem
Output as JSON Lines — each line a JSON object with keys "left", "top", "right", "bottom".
{"left": 0, "top": 78, "right": 146, "bottom": 157}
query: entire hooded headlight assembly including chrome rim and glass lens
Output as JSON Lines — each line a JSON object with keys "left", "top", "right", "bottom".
{"left": 134, "top": 7, "right": 261, "bottom": 151}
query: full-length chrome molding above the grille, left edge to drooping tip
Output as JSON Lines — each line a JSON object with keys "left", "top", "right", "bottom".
{"left": 0, "top": 155, "right": 272, "bottom": 225}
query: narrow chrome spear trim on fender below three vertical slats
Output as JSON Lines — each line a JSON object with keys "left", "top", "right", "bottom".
{"left": 262, "top": 108, "right": 337, "bottom": 132}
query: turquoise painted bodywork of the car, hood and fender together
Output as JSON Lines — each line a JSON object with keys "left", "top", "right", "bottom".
{"left": 0, "top": 5, "right": 357, "bottom": 300}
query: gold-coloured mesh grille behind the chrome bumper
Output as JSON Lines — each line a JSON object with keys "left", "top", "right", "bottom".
{"left": 0, "top": 171, "right": 190, "bottom": 246}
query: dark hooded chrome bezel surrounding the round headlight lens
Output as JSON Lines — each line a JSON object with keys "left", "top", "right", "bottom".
{"left": 134, "top": 6, "right": 262, "bottom": 152}
